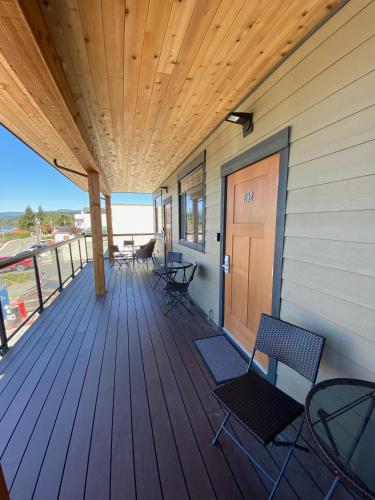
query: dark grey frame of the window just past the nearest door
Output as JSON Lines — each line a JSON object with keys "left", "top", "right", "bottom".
{"left": 177, "top": 151, "right": 206, "bottom": 253}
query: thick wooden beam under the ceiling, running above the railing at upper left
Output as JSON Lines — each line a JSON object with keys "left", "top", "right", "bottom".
{"left": 0, "top": 0, "right": 109, "bottom": 193}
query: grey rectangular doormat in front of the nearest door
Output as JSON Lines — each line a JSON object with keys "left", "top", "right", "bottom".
{"left": 194, "top": 335, "right": 249, "bottom": 384}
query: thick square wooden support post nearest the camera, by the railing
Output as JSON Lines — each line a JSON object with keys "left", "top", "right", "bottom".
{"left": 88, "top": 171, "right": 106, "bottom": 295}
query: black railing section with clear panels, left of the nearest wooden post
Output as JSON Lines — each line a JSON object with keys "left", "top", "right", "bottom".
{"left": 0, "top": 236, "right": 90, "bottom": 352}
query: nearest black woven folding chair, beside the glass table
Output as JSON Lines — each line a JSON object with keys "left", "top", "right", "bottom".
{"left": 212, "top": 314, "right": 325, "bottom": 499}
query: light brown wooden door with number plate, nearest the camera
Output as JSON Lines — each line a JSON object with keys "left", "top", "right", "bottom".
{"left": 224, "top": 154, "right": 280, "bottom": 370}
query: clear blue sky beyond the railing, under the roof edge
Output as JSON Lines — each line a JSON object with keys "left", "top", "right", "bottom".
{"left": 0, "top": 125, "right": 151, "bottom": 212}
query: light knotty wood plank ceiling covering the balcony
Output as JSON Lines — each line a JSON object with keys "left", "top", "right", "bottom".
{"left": 0, "top": 0, "right": 345, "bottom": 192}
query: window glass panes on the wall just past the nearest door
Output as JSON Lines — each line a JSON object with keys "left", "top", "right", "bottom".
{"left": 179, "top": 164, "right": 205, "bottom": 252}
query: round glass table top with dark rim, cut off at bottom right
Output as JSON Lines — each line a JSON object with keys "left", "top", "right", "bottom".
{"left": 306, "top": 378, "right": 375, "bottom": 498}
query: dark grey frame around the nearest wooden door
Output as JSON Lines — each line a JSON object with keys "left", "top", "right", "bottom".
{"left": 219, "top": 127, "right": 290, "bottom": 383}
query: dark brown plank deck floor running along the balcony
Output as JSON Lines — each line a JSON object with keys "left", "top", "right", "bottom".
{"left": 0, "top": 265, "right": 352, "bottom": 500}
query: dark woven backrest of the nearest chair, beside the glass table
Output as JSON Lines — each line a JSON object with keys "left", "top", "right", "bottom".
{"left": 254, "top": 314, "right": 325, "bottom": 383}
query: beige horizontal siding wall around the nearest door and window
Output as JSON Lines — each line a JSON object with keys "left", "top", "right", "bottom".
{"left": 161, "top": 0, "right": 375, "bottom": 398}
